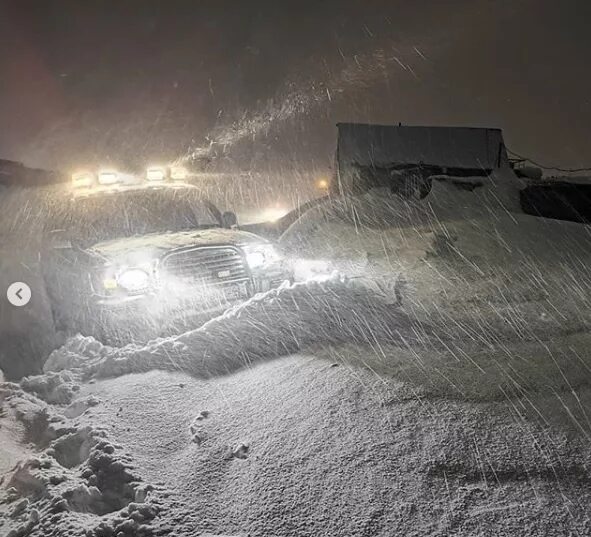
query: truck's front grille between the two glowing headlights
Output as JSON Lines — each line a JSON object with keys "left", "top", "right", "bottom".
{"left": 161, "top": 246, "right": 249, "bottom": 285}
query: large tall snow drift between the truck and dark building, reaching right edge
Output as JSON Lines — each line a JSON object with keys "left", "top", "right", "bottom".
{"left": 281, "top": 178, "right": 591, "bottom": 338}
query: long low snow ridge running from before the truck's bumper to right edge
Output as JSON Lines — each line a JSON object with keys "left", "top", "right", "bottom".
{"left": 45, "top": 264, "right": 591, "bottom": 406}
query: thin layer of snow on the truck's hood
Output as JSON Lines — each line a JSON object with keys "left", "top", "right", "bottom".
{"left": 89, "top": 228, "right": 268, "bottom": 258}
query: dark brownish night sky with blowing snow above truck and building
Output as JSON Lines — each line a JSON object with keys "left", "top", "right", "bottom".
{"left": 0, "top": 0, "right": 591, "bottom": 175}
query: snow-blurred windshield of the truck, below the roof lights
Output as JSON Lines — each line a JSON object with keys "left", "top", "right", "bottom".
{"left": 47, "top": 185, "right": 221, "bottom": 244}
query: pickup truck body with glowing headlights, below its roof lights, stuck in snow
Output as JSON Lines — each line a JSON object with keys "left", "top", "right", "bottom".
{"left": 42, "top": 183, "right": 290, "bottom": 344}
